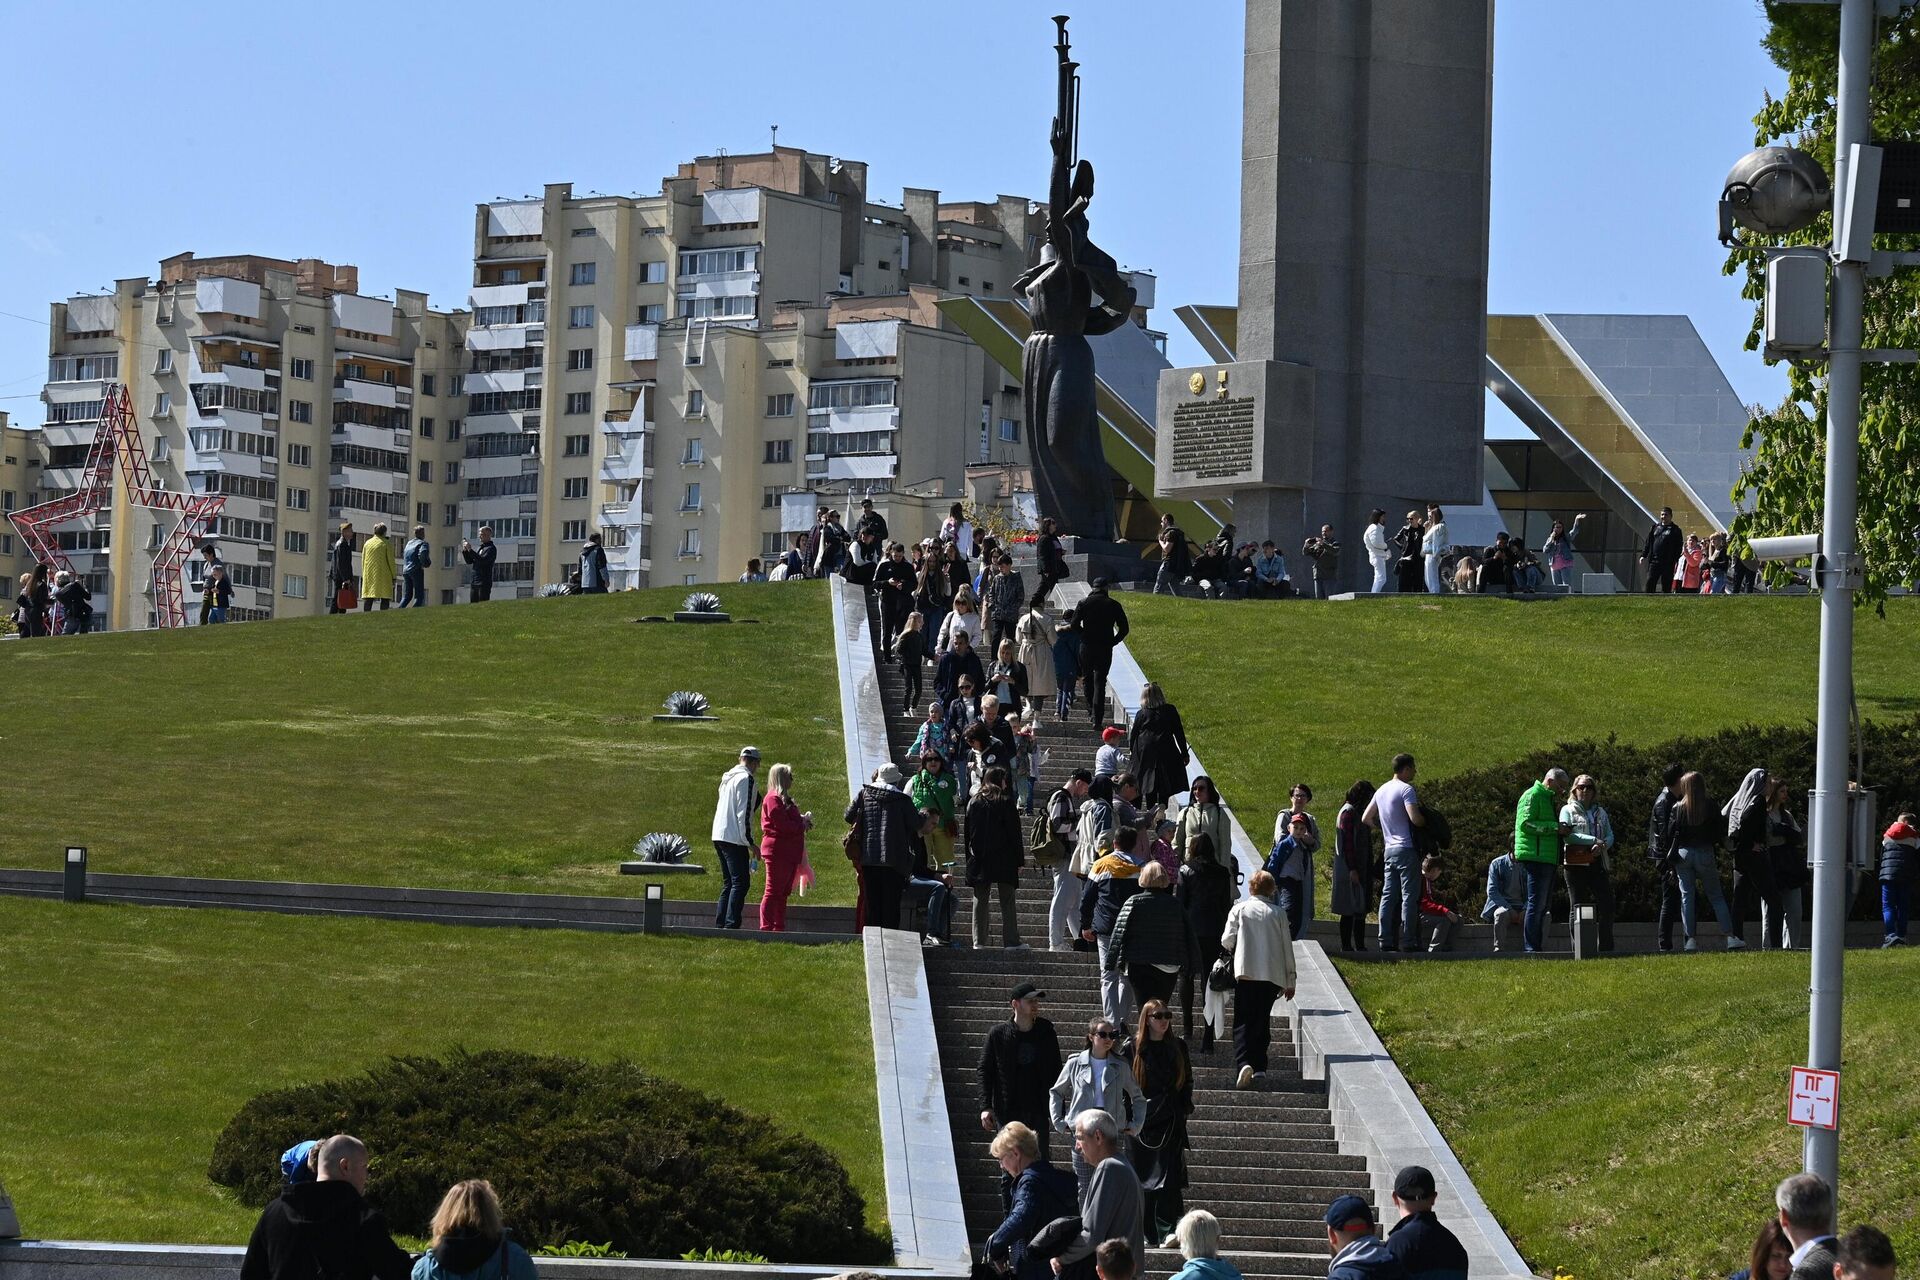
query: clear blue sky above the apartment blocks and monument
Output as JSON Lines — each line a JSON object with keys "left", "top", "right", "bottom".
{"left": 0, "top": 0, "right": 1784, "bottom": 430}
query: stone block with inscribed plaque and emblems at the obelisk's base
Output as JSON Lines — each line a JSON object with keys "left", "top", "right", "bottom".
{"left": 1154, "top": 361, "right": 1313, "bottom": 497}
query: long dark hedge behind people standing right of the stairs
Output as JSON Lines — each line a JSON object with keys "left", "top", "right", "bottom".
{"left": 1421, "top": 716, "right": 1920, "bottom": 921}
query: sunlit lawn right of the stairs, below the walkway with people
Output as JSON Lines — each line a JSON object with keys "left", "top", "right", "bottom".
{"left": 1336, "top": 952, "right": 1920, "bottom": 1280}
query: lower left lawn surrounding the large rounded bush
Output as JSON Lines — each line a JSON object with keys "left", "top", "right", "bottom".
{"left": 0, "top": 898, "right": 887, "bottom": 1244}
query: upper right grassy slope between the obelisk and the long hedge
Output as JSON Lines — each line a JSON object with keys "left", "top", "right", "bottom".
{"left": 1121, "top": 595, "right": 1920, "bottom": 859}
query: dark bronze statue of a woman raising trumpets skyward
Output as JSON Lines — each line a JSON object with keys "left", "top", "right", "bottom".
{"left": 1014, "top": 15, "right": 1135, "bottom": 541}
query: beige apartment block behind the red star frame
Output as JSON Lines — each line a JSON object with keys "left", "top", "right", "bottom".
{"left": 31, "top": 253, "right": 467, "bottom": 629}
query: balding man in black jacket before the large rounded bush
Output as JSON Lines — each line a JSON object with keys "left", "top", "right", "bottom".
{"left": 240, "top": 1134, "right": 413, "bottom": 1280}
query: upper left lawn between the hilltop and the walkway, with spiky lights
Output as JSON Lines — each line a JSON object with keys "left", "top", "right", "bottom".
{"left": 0, "top": 583, "right": 852, "bottom": 904}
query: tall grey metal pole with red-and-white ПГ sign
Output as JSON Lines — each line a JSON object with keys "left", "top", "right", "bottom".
{"left": 1803, "top": 0, "right": 1874, "bottom": 1192}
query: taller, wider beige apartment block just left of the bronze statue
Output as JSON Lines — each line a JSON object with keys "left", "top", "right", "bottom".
{"left": 461, "top": 148, "right": 1082, "bottom": 595}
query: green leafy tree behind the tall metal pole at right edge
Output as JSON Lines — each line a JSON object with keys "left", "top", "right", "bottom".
{"left": 1726, "top": 2, "right": 1920, "bottom": 606}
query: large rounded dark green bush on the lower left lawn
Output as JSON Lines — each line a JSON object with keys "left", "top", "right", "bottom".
{"left": 209, "top": 1052, "right": 891, "bottom": 1263}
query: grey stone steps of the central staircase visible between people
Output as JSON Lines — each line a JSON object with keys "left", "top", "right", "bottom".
{"left": 874, "top": 594, "right": 1371, "bottom": 1278}
